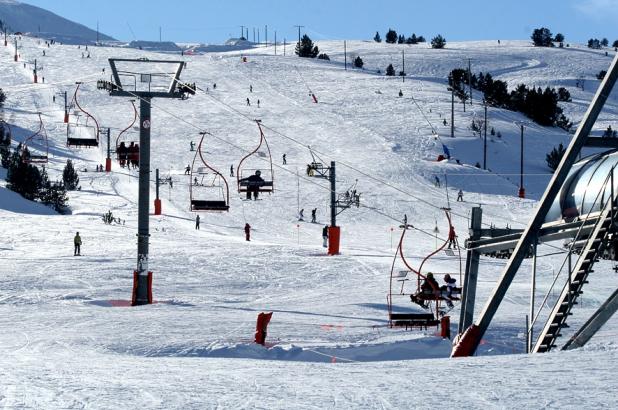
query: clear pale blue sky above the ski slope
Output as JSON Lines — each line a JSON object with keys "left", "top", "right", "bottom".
{"left": 22, "top": 0, "right": 618, "bottom": 44}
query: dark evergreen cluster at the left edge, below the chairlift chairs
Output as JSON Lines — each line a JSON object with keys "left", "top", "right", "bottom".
{"left": 2, "top": 146, "right": 68, "bottom": 213}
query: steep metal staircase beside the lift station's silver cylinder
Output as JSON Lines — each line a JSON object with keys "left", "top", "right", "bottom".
{"left": 532, "top": 198, "right": 616, "bottom": 353}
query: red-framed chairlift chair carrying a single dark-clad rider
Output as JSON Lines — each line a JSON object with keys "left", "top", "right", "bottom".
{"left": 236, "top": 120, "right": 274, "bottom": 193}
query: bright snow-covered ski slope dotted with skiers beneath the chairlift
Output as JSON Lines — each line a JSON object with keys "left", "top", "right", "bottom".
{"left": 0, "top": 37, "right": 618, "bottom": 408}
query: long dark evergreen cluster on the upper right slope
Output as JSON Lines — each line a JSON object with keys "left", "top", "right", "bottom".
{"left": 449, "top": 68, "right": 573, "bottom": 131}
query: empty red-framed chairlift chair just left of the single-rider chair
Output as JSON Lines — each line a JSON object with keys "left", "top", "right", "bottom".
{"left": 189, "top": 133, "right": 230, "bottom": 212}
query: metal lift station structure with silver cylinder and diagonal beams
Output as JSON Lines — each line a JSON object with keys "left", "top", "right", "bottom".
{"left": 451, "top": 55, "right": 618, "bottom": 357}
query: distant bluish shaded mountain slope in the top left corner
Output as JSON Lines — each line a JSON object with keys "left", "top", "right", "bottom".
{"left": 0, "top": 0, "right": 114, "bottom": 44}
